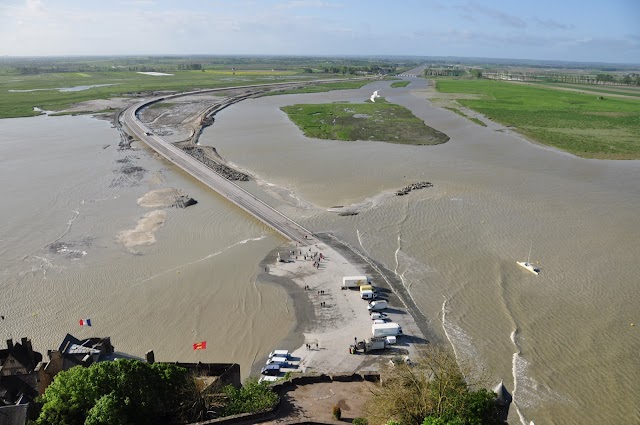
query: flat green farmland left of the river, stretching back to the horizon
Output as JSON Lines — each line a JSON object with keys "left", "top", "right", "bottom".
{"left": 0, "top": 55, "right": 417, "bottom": 118}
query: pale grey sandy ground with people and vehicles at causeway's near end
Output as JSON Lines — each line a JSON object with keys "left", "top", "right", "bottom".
{"left": 254, "top": 234, "right": 431, "bottom": 374}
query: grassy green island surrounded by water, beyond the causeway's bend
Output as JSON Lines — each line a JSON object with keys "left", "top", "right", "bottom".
{"left": 281, "top": 99, "right": 449, "bottom": 145}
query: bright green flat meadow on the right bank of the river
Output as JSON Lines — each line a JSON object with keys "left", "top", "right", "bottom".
{"left": 437, "top": 79, "right": 640, "bottom": 159}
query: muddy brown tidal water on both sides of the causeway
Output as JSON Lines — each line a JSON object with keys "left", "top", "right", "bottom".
{"left": 0, "top": 80, "right": 640, "bottom": 424}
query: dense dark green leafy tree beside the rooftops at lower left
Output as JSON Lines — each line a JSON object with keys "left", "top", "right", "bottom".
{"left": 36, "top": 360, "right": 193, "bottom": 425}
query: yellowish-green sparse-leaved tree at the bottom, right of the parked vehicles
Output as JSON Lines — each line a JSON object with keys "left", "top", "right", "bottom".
{"left": 366, "top": 348, "right": 501, "bottom": 425}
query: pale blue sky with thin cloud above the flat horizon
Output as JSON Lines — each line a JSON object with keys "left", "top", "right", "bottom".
{"left": 0, "top": 0, "right": 640, "bottom": 64}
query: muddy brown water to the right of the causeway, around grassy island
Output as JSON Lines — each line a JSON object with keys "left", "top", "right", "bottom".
{"left": 201, "top": 79, "right": 640, "bottom": 424}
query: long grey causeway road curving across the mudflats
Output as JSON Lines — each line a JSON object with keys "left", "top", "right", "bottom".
{"left": 122, "top": 83, "right": 328, "bottom": 245}
